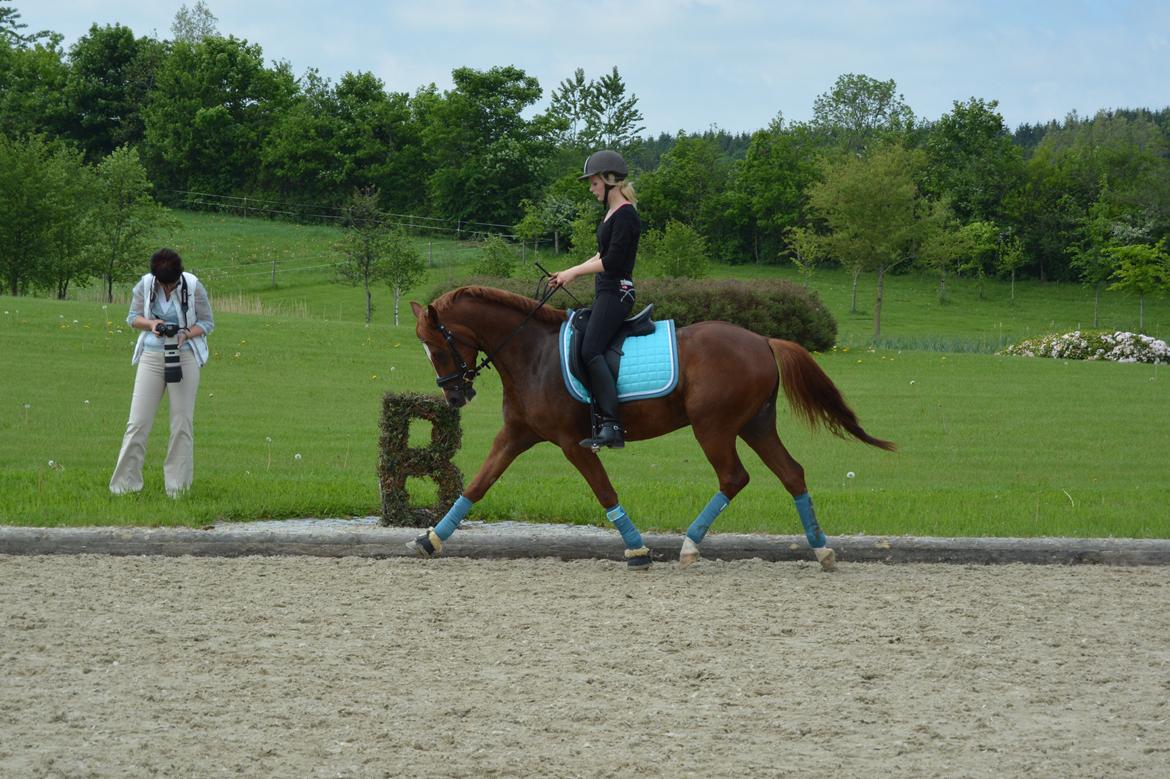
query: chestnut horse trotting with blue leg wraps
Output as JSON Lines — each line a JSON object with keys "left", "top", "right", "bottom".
{"left": 408, "top": 287, "right": 894, "bottom": 571}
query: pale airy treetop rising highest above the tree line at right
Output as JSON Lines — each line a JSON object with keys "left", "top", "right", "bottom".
{"left": 812, "top": 73, "right": 914, "bottom": 153}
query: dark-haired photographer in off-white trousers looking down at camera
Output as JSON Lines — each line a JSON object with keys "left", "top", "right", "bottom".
{"left": 110, "top": 249, "right": 214, "bottom": 497}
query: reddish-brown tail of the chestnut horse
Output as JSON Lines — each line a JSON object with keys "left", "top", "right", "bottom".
{"left": 768, "top": 338, "right": 897, "bottom": 451}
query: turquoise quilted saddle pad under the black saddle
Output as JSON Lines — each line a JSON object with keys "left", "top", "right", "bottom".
{"left": 559, "top": 316, "right": 679, "bottom": 404}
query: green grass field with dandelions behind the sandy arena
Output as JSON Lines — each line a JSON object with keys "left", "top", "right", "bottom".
{"left": 0, "top": 208, "right": 1170, "bottom": 538}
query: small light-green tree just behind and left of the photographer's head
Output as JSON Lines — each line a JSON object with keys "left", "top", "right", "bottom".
{"left": 91, "top": 146, "right": 170, "bottom": 303}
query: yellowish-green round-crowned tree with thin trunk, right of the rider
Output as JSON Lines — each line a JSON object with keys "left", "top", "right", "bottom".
{"left": 810, "top": 144, "right": 924, "bottom": 343}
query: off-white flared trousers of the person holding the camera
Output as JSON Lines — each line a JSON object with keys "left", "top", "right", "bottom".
{"left": 110, "top": 349, "right": 199, "bottom": 497}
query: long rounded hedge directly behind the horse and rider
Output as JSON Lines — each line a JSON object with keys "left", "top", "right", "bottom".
{"left": 431, "top": 276, "right": 837, "bottom": 351}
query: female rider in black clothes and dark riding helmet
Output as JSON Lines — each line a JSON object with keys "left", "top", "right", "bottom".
{"left": 549, "top": 150, "right": 642, "bottom": 449}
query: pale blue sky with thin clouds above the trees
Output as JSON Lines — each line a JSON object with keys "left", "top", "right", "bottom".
{"left": 16, "top": 0, "right": 1170, "bottom": 135}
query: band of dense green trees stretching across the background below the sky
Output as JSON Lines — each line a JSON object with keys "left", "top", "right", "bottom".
{"left": 0, "top": 0, "right": 1170, "bottom": 334}
